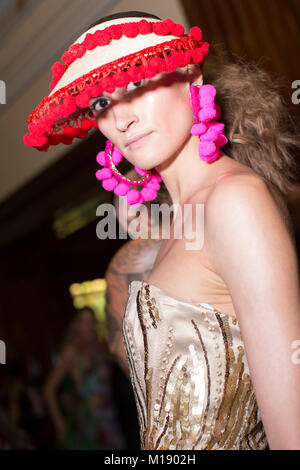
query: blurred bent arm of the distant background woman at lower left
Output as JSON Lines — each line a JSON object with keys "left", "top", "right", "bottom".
{"left": 43, "top": 345, "right": 74, "bottom": 438}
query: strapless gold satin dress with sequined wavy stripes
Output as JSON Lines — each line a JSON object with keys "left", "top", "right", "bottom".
{"left": 122, "top": 281, "right": 269, "bottom": 450}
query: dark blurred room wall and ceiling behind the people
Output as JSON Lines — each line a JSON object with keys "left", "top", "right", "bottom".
{"left": 0, "top": 0, "right": 300, "bottom": 449}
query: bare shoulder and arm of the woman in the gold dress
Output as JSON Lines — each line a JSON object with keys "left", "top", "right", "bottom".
{"left": 204, "top": 175, "right": 300, "bottom": 449}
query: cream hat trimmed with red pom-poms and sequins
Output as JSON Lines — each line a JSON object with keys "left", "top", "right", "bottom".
{"left": 24, "top": 17, "right": 209, "bottom": 152}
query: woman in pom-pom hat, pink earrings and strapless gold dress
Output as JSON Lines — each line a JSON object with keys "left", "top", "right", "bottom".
{"left": 25, "top": 12, "right": 300, "bottom": 450}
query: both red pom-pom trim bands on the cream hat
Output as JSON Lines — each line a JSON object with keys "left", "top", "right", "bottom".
{"left": 24, "top": 28, "right": 209, "bottom": 152}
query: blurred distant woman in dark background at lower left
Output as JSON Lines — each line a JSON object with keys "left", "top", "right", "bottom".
{"left": 44, "top": 307, "right": 124, "bottom": 450}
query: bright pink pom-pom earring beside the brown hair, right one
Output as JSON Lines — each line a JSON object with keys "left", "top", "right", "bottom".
{"left": 190, "top": 84, "right": 228, "bottom": 162}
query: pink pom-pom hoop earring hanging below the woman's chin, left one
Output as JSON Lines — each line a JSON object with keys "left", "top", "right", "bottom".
{"left": 96, "top": 140, "right": 162, "bottom": 206}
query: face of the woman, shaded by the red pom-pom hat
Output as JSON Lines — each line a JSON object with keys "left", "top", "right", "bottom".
{"left": 89, "top": 69, "right": 197, "bottom": 170}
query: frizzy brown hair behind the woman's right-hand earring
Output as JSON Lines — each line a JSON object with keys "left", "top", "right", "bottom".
{"left": 203, "top": 45, "right": 300, "bottom": 196}
